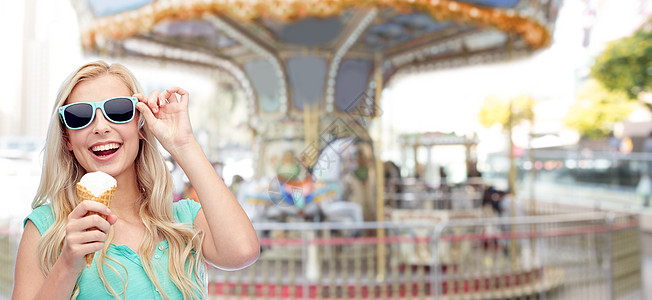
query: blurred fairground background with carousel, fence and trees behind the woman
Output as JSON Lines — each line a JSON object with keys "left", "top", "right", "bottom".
{"left": 0, "top": 0, "right": 652, "bottom": 299}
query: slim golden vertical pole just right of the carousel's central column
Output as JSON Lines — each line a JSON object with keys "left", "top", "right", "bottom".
{"left": 374, "top": 52, "right": 385, "bottom": 282}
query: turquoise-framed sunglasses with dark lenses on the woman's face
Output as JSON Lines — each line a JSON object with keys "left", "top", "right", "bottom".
{"left": 59, "top": 97, "right": 138, "bottom": 130}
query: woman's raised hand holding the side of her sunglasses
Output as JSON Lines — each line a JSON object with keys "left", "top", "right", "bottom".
{"left": 134, "top": 87, "right": 194, "bottom": 154}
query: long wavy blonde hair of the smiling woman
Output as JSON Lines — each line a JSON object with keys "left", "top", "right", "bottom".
{"left": 32, "top": 61, "right": 205, "bottom": 299}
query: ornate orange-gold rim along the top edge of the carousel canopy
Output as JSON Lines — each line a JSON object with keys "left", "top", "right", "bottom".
{"left": 82, "top": 0, "right": 550, "bottom": 49}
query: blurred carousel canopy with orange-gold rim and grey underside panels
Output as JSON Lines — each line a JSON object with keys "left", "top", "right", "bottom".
{"left": 72, "top": 0, "right": 560, "bottom": 115}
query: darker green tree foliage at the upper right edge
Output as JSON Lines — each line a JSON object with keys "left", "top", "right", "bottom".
{"left": 591, "top": 19, "right": 652, "bottom": 103}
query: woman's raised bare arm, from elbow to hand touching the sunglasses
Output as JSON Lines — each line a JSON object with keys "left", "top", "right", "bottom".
{"left": 135, "top": 87, "right": 260, "bottom": 269}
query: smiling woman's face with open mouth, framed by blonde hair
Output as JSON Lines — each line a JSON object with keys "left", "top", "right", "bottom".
{"left": 65, "top": 75, "right": 139, "bottom": 178}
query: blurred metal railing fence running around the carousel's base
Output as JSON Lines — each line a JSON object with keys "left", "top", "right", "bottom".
{"left": 0, "top": 212, "right": 649, "bottom": 299}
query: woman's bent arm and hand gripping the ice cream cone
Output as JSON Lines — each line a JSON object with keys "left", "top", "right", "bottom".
{"left": 11, "top": 201, "right": 117, "bottom": 299}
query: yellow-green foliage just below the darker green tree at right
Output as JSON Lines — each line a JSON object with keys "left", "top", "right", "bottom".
{"left": 564, "top": 80, "right": 635, "bottom": 139}
